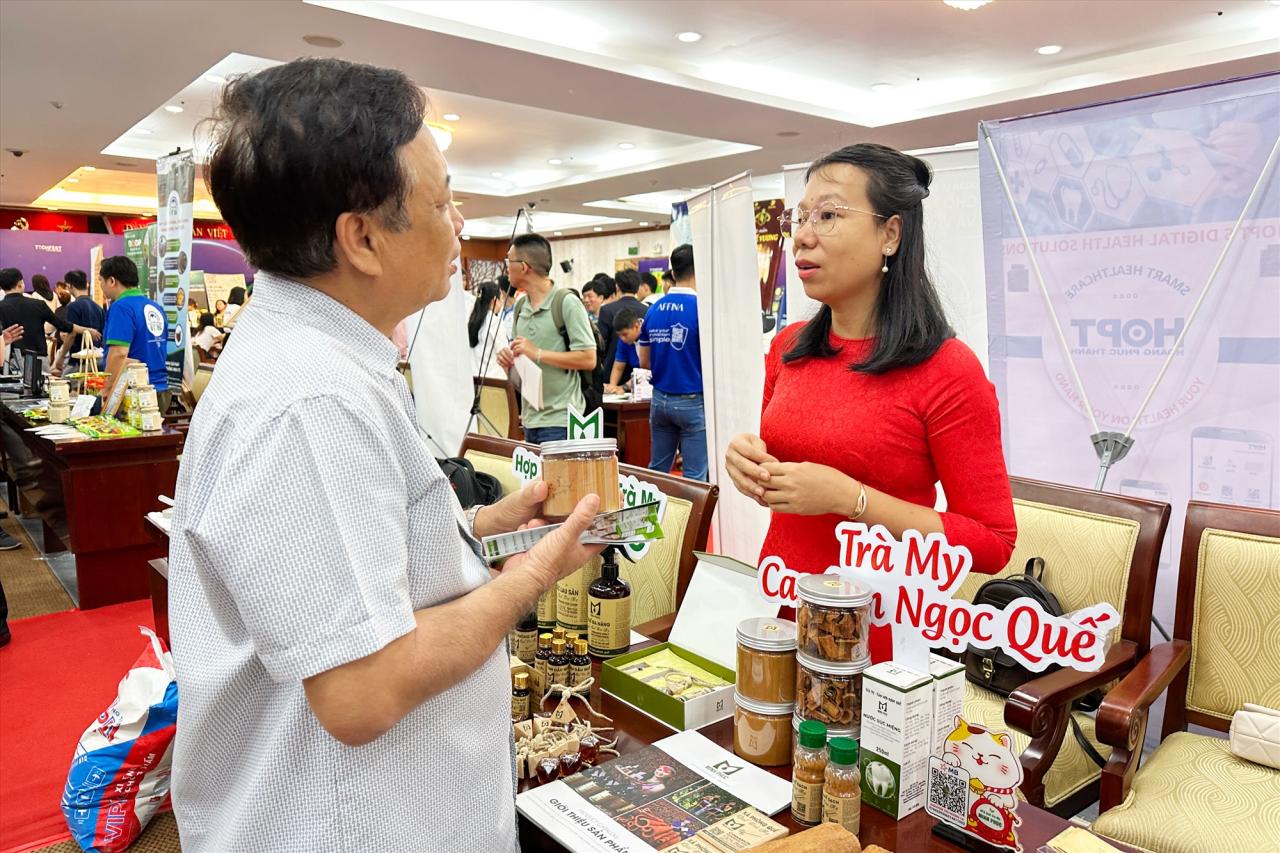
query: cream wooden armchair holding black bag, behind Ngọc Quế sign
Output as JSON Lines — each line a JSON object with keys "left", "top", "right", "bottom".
{"left": 956, "top": 476, "right": 1169, "bottom": 816}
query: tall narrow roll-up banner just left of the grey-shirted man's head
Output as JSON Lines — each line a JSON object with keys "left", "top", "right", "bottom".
{"left": 155, "top": 151, "right": 196, "bottom": 388}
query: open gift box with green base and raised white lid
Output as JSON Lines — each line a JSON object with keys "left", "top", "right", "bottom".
{"left": 600, "top": 552, "right": 778, "bottom": 731}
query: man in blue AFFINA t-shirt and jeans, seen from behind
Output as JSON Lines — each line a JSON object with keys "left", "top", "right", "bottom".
{"left": 636, "top": 243, "right": 707, "bottom": 480}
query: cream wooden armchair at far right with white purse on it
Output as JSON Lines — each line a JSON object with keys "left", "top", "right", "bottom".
{"left": 1093, "top": 501, "right": 1280, "bottom": 853}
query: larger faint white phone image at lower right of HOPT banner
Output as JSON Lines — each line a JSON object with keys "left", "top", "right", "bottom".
{"left": 1192, "top": 427, "right": 1275, "bottom": 510}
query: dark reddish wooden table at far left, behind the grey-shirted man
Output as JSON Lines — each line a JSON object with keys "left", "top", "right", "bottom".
{"left": 0, "top": 398, "right": 183, "bottom": 610}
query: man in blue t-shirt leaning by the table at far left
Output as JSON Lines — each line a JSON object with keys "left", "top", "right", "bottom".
{"left": 99, "top": 255, "right": 170, "bottom": 412}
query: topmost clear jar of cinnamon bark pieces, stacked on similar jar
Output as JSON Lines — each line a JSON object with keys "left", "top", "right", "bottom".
{"left": 796, "top": 575, "right": 872, "bottom": 663}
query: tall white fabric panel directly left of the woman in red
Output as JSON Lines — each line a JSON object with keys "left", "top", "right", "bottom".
{"left": 689, "top": 173, "right": 769, "bottom": 565}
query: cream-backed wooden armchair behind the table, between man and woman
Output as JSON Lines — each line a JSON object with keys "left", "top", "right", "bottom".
{"left": 458, "top": 433, "right": 719, "bottom": 625}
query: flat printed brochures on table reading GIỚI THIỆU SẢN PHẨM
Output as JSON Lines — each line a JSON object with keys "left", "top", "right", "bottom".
{"left": 516, "top": 731, "right": 791, "bottom": 853}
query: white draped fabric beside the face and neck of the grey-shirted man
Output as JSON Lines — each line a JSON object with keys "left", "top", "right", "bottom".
{"left": 404, "top": 267, "right": 474, "bottom": 457}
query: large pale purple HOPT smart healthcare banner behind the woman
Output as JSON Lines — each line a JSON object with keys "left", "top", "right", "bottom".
{"left": 979, "top": 74, "right": 1280, "bottom": 712}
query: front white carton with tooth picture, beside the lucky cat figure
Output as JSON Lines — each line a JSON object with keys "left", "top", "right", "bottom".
{"left": 858, "top": 662, "right": 933, "bottom": 820}
